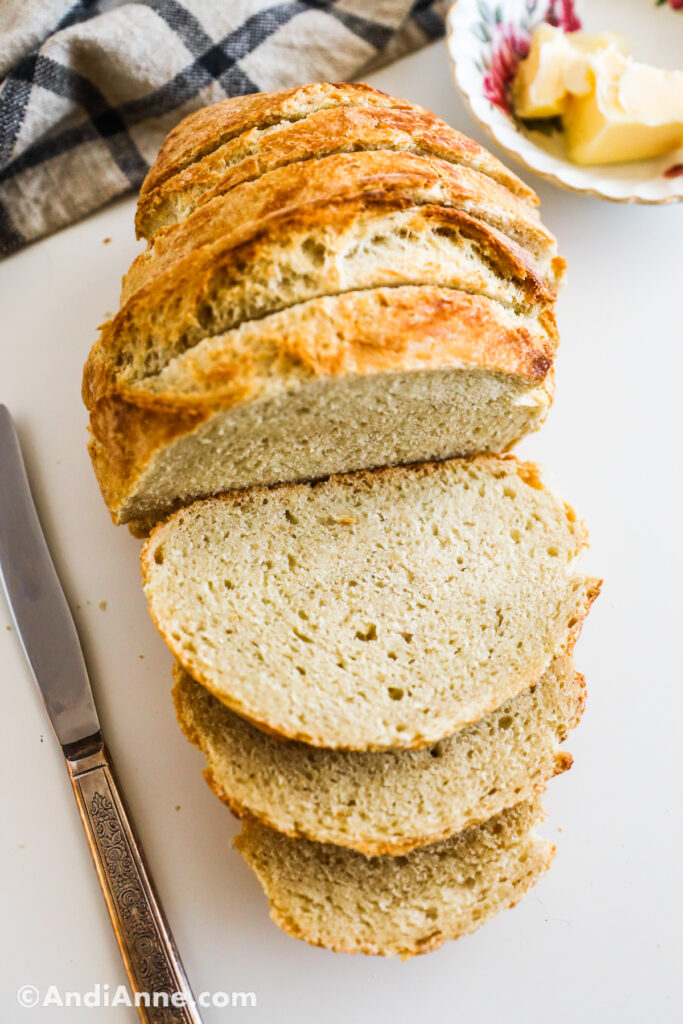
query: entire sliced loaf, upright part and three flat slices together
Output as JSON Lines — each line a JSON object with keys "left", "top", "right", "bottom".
{"left": 76, "top": 83, "right": 600, "bottom": 956}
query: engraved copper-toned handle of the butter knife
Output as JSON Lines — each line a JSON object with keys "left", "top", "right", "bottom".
{"left": 66, "top": 736, "right": 202, "bottom": 1024}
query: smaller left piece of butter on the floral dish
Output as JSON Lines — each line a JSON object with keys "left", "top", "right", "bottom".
{"left": 512, "top": 25, "right": 625, "bottom": 118}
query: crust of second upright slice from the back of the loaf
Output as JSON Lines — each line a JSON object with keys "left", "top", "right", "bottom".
{"left": 135, "top": 104, "right": 538, "bottom": 238}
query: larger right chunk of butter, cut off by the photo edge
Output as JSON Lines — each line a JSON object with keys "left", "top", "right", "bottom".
{"left": 563, "top": 50, "right": 683, "bottom": 164}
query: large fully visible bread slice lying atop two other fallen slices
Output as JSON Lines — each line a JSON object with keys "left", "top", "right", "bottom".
{"left": 142, "top": 457, "right": 598, "bottom": 750}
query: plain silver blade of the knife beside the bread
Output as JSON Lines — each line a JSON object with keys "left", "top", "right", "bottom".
{"left": 0, "top": 406, "right": 99, "bottom": 746}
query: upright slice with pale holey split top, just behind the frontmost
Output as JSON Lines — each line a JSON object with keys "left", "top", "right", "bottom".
{"left": 84, "top": 196, "right": 555, "bottom": 409}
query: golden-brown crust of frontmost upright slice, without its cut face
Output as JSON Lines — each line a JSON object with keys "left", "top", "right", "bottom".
{"left": 85, "top": 287, "right": 557, "bottom": 524}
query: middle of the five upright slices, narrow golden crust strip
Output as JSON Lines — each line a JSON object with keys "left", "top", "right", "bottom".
{"left": 121, "top": 151, "right": 563, "bottom": 302}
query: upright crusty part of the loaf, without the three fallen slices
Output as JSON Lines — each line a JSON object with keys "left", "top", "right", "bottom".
{"left": 83, "top": 85, "right": 563, "bottom": 531}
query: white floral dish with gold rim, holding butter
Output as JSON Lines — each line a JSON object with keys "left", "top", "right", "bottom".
{"left": 447, "top": 0, "right": 683, "bottom": 203}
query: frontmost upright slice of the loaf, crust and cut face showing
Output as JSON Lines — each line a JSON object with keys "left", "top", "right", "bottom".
{"left": 90, "top": 286, "right": 556, "bottom": 532}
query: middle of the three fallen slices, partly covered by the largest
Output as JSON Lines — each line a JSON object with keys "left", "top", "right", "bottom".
{"left": 173, "top": 655, "right": 586, "bottom": 855}
